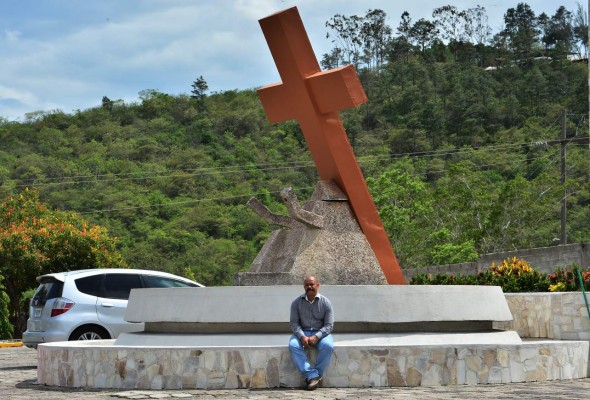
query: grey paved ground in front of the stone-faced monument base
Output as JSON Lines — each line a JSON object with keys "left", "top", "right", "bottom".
{"left": 0, "top": 347, "right": 590, "bottom": 400}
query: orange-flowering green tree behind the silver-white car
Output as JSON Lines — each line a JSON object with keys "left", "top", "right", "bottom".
{"left": 0, "top": 190, "right": 125, "bottom": 332}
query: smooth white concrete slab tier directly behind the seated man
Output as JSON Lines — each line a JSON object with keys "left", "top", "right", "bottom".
{"left": 125, "top": 285, "right": 512, "bottom": 333}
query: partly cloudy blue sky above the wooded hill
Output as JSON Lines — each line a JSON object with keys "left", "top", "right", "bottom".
{"left": 0, "top": 0, "right": 588, "bottom": 121}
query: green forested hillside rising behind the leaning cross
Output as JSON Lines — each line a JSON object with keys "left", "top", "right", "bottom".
{"left": 0, "top": 3, "right": 590, "bottom": 285}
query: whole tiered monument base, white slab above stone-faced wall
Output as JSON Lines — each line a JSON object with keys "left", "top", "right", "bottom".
{"left": 37, "top": 285, "right": 589, "bottom": 389}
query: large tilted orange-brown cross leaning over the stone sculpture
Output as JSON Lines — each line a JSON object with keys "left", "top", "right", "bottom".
{"left": 258, "top": 7, "right": 405, "bottom": 284}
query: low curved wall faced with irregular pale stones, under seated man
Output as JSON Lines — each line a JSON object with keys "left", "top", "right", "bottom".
{"left": 37, "top": 341, "right": 588, "bottom": 389}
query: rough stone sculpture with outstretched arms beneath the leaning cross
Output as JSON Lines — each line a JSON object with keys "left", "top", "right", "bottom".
{"left": 235, "top": 181, "right": 387, "bottom": 286}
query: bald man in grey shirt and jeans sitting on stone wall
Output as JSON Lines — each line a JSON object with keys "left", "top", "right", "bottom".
{"left": 289, "top": 276, "right": 334, "bottom": 390}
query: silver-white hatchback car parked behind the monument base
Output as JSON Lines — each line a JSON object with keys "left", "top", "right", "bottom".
{"left": 23, "top": 269, "right": 203, "bottom": 348}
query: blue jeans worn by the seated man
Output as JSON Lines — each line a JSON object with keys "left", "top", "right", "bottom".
{"left": 289, "top": 331, "right": 334, "bottom": 381}
